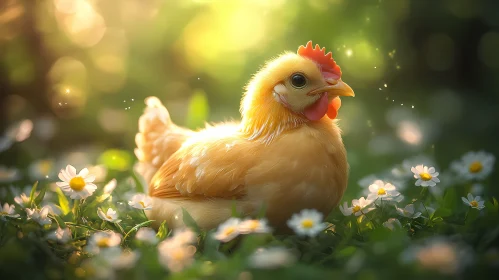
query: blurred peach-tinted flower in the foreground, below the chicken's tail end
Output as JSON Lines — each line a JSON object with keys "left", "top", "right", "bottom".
{"left": 158, "top": 240, "right": 196, "bottom": 272}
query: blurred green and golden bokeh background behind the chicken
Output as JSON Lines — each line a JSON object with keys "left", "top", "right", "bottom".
{"left": 0, "top": 0, "right": 499, "bottom": 197}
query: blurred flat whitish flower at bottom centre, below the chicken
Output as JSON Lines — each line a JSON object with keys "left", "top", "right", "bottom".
{"left": 248, "top": 247, "right": 296, "bottom": 269}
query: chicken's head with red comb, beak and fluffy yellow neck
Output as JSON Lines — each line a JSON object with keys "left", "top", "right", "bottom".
{"left": 241, "top": 41, "right": 354, "bottom": 141}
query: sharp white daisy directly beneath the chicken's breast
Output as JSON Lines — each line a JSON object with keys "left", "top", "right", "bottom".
{"left": 287, "top": 209, "right": 327, "bottom": 237}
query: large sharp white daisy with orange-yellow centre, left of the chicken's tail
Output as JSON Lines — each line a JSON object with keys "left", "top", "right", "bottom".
{"left": 56, "top": 165, "right": 97, "bottom": 199}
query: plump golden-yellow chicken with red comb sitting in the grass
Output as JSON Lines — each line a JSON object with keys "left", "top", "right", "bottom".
{"left": 136, "top": 42, "right": 354, "bottom": 231}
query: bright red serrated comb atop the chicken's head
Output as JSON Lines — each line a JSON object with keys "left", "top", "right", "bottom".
{"left": 297, "top": 41, "right": 341, "bottom": 79}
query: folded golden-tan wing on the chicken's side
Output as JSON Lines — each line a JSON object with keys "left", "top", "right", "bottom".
{"left": 149, "top": 124, "right": 258, "bottom": 198}
